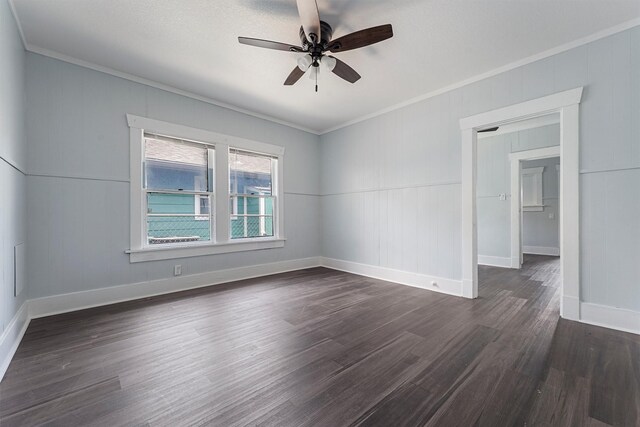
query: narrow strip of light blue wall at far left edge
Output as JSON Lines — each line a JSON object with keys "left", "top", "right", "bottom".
{"left": 0, "top": 0, "right": 27, "bottom": 334}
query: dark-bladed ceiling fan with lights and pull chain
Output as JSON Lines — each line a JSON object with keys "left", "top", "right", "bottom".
{"left": 238, "top": 0, "right": 393, "bottom": 92}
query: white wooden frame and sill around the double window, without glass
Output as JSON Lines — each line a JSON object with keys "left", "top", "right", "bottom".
{"left": 125, "top": 114, "right": 286, "bottom": 263}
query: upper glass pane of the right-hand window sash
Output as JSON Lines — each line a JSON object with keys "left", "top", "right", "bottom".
{"left": 229, "top": 149, "right": 273, "bottom": 195}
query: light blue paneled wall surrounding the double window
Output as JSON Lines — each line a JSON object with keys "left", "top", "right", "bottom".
{"left": 27, "top": 53, "right": 320, "bottom": 298}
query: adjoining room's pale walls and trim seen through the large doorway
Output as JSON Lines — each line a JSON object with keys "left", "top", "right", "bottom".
{"left": 476, "top": 113, "right": 560, "bottom": 268}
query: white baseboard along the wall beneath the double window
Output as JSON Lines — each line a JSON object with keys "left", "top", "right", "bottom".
{"left": 29, "top": 257, "right": 320, "bottom": 319}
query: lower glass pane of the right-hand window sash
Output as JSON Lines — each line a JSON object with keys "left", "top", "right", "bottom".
{"left": 230, "top": 196, "right": 274, "bottom": 239}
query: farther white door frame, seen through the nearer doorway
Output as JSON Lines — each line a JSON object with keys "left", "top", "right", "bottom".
{"left": 509, "top": 145, "right": 562, "bottom": 268}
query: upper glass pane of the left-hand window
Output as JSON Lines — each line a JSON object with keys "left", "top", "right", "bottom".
{"left": 144, "top": 136, "right": 208, "bottom": 191}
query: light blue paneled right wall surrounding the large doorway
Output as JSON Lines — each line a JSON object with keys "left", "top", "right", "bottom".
{"left": 321, "top": 27, "right": 640, "bottom": 311}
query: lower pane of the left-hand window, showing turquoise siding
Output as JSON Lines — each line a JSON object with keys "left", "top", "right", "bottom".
{"left": 147, "top": 193, "right": 211, "bottom": 245}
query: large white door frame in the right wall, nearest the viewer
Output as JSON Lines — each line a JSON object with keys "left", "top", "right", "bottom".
{"left": 460, "top": 87, "right": 582, "bottom": 320}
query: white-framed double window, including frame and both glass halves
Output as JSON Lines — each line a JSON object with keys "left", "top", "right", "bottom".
{"left": 126, "top": 115, "right": 284, "bottom": 262}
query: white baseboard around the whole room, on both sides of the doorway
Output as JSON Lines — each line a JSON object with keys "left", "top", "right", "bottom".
{"left": 0, "top": 257, "right": 640, "bottom": 380}
